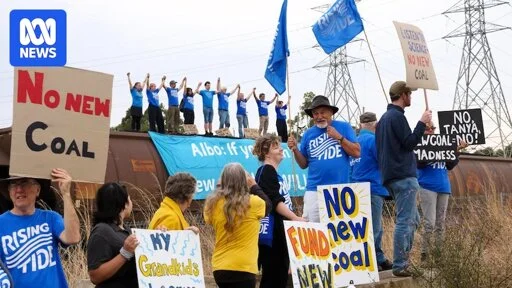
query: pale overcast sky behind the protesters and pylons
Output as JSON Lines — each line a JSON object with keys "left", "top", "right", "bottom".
{"left": 0, "top": 0, "right": 512, "bottom": 148}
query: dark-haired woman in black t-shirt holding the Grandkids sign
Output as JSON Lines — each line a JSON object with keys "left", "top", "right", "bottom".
{"left": 87, "top": 183, "right": 139, "bottom": 288}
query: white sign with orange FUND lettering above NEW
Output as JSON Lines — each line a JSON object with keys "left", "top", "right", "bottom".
{"left": 284, "top": 221, "right": 334, "bottom": 288}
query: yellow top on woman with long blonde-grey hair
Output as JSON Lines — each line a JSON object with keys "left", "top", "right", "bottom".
{"left": 204, "top": 195, "right": 265, "bottom": 274}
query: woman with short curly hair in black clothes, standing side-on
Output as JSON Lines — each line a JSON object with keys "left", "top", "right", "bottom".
{"left": 252, "top": 134, "right": 304, "bottom": 288}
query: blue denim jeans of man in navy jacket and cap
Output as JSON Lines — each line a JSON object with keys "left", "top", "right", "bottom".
{"left": 386, "top": 177, "right": 420, "bottom": 271}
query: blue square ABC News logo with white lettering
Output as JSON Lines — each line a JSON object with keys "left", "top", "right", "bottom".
{"left": 10, "top": 10, "right": 67, "bottom": 66}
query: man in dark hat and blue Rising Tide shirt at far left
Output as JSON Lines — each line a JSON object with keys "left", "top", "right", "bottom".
{"left": 0, "top": 168, "right": 80, "bottom": 287}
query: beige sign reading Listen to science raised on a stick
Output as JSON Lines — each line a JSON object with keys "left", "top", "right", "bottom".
{"left": 393, "top": 21, "right": 439, "bottom": 90}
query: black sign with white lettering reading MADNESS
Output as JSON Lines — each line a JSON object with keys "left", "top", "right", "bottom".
{"left": 414, "top": 134, "right": 457, "bottom": 162}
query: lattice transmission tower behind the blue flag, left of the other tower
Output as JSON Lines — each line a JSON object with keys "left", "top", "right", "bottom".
{"left": 312, "top": 4, "right": 364, "bottom": 126}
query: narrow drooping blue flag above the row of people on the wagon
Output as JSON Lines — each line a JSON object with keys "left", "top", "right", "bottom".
{"left": 265, "top": 0, "right": 290, "bottom": 94}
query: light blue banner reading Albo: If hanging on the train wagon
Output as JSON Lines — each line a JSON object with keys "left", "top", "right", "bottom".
{"left": 149, "top": 132, "right": 308, "bottom": 199}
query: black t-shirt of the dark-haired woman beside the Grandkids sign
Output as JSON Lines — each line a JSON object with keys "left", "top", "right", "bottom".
{"left": 87, "top": 223, "right": 138, "bottom": 288}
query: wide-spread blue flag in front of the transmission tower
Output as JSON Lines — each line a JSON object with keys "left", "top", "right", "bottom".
{"left": 313, "top": 0, "right": 364, "bottom": 54}
